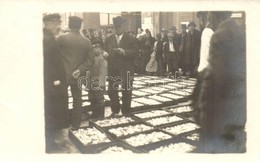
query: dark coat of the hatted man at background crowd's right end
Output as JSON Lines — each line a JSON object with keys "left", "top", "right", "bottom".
{"left": 184, "top": 30, "right": 201, "bottom": 66}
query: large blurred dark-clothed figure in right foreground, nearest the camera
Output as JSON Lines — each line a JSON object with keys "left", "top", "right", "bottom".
{"left": 199, "top": 14, "right": 246, "bottom": 153}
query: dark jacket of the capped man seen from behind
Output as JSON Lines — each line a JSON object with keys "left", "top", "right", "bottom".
{"left": 57, "top": 32, "right": 94, "bottom": 84}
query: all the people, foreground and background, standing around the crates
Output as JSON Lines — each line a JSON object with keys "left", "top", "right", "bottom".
{"left": 43, "top": 11, "right": 246, "bottom": 153}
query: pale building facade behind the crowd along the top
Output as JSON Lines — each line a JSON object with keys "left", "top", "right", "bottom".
{"left": 54, "top": 11, "right": 245, "bottom": 36}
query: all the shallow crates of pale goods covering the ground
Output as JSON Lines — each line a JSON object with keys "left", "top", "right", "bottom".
{"left": 69, "top": 76, "right": 200, "bottom": 153}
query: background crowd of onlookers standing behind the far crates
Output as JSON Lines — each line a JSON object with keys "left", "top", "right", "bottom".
{"left": 76, "top": 21, "right": 201, "bottom": 77}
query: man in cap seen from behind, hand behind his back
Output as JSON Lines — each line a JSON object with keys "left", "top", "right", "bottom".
{"left": 57, "top": 16, "right": 94, "bottom": 129}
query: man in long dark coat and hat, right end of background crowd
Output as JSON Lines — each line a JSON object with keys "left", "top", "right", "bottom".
{"left": 184, "top": 22, "right": 201, "bottom": 77}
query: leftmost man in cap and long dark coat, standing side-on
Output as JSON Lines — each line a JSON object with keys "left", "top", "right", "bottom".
{"left": 43, "top": 14, "right": 69, "bottom": 152}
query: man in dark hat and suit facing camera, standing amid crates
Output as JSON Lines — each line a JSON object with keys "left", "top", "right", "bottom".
{"left": 105, "top": 16, "right": 138, "bottom": 116}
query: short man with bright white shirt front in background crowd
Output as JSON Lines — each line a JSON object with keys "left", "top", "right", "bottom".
{"left": 163, "top": 33, "right": 179, "bottom": 75}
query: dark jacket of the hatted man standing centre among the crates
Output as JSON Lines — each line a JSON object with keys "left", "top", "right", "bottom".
{"left": 104, "top": 33, "right": 138, "bottom": 74}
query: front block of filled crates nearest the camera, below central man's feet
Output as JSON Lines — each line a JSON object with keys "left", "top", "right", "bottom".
{"left": 69, "top": 105, "right": 200, "bottom": 153}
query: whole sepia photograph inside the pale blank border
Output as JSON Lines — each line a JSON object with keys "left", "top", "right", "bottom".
{"left": 43, "top": 11, "right": 246, "bottom": 153}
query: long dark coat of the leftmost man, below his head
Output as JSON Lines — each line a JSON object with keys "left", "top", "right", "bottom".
{"left": 43, "top": 29, "right": 68, "bottom": 129}
